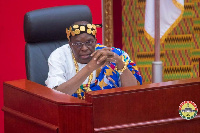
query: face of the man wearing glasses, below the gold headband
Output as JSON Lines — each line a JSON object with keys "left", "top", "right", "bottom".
{"left": 69, "top": 33, "right": 96, "bottom": 64}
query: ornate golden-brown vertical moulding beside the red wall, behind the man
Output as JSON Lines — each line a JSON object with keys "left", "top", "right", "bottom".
{"left": 102, "top": 0, "right": 114, "bottom": 47}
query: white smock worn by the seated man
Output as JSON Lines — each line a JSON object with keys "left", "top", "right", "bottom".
{"left": 45, "top": 44, "right": 96, "bottom": 88}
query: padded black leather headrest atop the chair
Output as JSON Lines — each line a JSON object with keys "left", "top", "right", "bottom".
{"left": 24, "top": 5, "right": 92, "bottom": 43}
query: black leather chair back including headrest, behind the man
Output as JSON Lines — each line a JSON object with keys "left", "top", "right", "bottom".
{"left": 24, "top": 5, "right": 92, "bottom": 85}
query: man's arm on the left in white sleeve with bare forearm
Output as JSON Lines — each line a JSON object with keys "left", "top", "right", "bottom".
{"left": 45, "top": 47, "right": 102, "bottom": 95}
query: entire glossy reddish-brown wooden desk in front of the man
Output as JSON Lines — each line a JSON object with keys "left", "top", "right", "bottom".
{"left": 2, "top": 78, "right": 200, "bottom": 133}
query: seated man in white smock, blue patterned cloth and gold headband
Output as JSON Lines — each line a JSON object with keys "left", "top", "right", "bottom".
{"left": 45, "top": 21, "right": 142, "bottom": 99}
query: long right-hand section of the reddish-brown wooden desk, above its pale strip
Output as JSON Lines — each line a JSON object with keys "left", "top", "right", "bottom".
{"left": 86, "top": 78, "right": 200, "bottom": 130}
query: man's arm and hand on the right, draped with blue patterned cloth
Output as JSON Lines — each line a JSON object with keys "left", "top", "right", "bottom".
{"left": 93, "top": 48, "right": 142, "bottom": 87}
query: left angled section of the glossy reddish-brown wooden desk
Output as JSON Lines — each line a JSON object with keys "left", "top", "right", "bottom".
{"left": 2, "top": 80, "right": 94, "bottom": 133}
